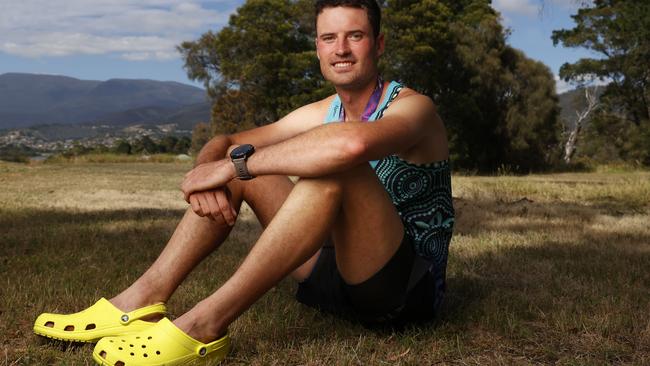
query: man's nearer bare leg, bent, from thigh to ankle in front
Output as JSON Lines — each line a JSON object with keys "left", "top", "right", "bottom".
{"left": 175, "top": 164, "right": 404, "bottom": 342}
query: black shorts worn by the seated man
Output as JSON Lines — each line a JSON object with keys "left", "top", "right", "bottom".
{"left": 296, "top": 235, "right": 437, "bottom": 327}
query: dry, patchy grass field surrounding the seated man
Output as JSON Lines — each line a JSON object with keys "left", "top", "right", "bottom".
{"left": 0, "top": 161, "right": 650, "bottom": 365}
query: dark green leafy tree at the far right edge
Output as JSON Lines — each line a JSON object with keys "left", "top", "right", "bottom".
{"left": 552, "top": 0, "right": 650, "bottom": 165}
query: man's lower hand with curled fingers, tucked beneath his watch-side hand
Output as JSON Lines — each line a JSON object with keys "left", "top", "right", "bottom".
{"left": 190, "top": 187, "right": 237, "bottom": 226}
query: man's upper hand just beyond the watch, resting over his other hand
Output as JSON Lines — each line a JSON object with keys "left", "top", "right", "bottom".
{"left": 181, "top": 159, "right": 237, "bottom": 203}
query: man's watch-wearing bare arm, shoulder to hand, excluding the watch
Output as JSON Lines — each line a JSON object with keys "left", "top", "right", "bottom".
{"left": 182, "top": 94, "right": 441, "bottom": 197}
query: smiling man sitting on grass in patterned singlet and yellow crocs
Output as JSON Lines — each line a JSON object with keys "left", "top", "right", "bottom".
{"left": 34, "top": 0, "right": 453, "bottom": 365}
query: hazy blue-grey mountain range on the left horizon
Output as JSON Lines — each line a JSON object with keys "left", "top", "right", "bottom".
{"left": 0, "top": 73, "right": 210, "bottom": 129}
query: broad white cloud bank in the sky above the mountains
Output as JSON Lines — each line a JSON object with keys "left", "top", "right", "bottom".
{"left": 0, "top": 0, "right": 232, "bottom": 60}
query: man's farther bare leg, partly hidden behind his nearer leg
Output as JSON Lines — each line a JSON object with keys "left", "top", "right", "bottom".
{"left": 109, "top": 176, "right": 293, "bottom": 311}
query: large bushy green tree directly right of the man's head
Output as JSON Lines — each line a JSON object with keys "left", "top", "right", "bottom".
{"left": 384, "top": 0, "right": 560, "bottom": 171}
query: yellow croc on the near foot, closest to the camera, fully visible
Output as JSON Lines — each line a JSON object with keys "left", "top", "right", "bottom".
{"left": 93, "top": 318, "right": 230, "bottom": 366}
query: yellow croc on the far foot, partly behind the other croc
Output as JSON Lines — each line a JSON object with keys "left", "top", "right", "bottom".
{"left": 34, "top": 297, "right": 167, "bottom": 342}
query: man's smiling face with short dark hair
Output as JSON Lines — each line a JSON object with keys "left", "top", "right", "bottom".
{"left": 316, "top": 6, "right": 384, "bottom": 89}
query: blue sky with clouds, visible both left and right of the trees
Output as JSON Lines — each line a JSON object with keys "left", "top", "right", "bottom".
{"left": 0, "top": 0, "right": 594, "bottom": 92}
